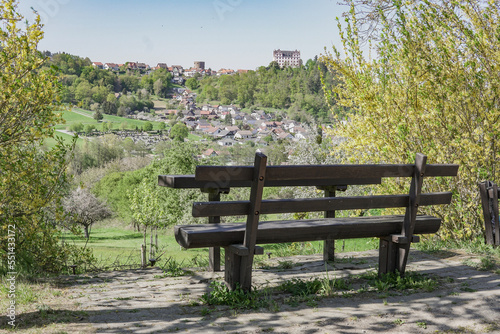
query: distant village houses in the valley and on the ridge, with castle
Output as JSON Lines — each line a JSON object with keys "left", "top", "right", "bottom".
{"left": 92, "top": 50, "right": 309, "bottom": 147}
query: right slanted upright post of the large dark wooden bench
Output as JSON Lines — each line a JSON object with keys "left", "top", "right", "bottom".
{"left": 398, "top": 153, "right": 427, "bottom": 275}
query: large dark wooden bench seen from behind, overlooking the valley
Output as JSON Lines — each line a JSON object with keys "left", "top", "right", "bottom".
{"left": 159, "top": 153, "right": 458, "bottom": 291}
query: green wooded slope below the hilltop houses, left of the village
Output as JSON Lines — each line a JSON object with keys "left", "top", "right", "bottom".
{"left": 45, "top": 52, "right": 172, "bottom": 116}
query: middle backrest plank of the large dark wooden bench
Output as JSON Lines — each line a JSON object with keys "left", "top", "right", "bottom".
{"left": 192, "top": 192, "right": 452, "bottom": 217}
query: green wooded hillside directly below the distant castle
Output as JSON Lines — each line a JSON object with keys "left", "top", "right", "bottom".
{"left": 197, "top": 59, "right": 337, "bottom": 121}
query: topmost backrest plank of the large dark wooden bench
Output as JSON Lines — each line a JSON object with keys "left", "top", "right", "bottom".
{"left": 195, "top": 164, "right": 458, "bottom": 181}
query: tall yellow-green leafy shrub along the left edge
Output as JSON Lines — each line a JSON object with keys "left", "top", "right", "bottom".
{"left": 0, "top": 0, "right": 77, "bottom": 271}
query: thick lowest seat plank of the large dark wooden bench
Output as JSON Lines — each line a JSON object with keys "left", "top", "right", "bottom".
{"left": 174, "top": 215, "right": 441, "bottom": 248}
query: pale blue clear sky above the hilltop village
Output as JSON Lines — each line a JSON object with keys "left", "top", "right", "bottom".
{"left": 19, "top": 0, "right": 347, "bottom": 70}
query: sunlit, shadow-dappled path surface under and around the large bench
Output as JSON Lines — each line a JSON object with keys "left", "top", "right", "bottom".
{"left": 4, "top": 251, "right": 500, "bottom": 334}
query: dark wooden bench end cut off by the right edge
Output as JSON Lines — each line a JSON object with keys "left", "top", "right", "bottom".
{"left": 479, "top": 181, "right": 500, "bottom": 246}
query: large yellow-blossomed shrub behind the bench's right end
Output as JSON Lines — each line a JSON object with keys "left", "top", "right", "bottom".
{"left": 322, "top": 0, "right": 500, "bottom": 240}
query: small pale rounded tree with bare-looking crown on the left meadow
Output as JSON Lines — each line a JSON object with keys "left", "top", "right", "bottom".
{"left": 64, "top": 188, "right": 111, "bottom": 239}
